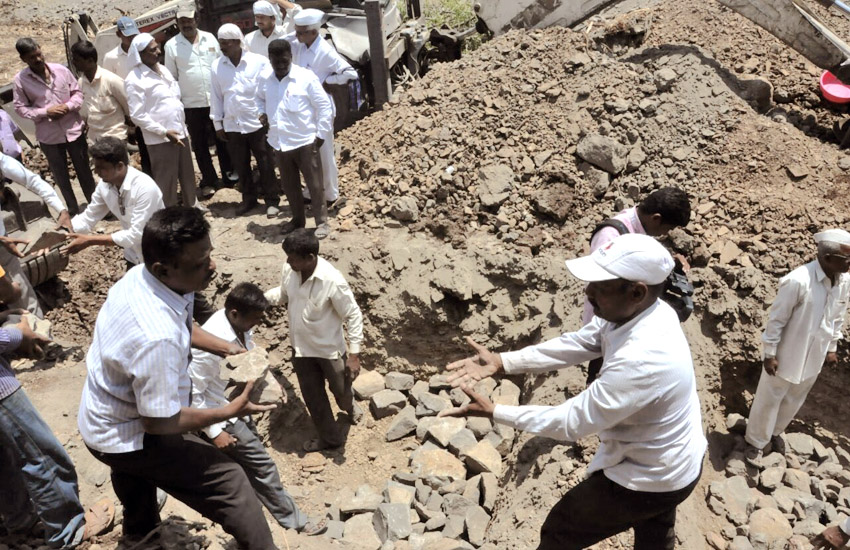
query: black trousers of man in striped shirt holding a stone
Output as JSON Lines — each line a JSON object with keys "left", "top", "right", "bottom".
{"left": 89, "top": 434, "right": 276, "bottom": 550}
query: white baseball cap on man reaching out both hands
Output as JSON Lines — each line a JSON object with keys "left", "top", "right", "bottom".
{"left": 567, "top": 233, "right": 675, "bottom": 285}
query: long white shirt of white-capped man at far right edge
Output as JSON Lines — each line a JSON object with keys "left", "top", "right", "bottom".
{"left": 762, "top": 260, "right": 850, "bottom": 384}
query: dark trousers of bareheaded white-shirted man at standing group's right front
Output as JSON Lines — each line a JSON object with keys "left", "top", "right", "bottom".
{"left": 275, "top": 143, "right": 328, "bottom": 227}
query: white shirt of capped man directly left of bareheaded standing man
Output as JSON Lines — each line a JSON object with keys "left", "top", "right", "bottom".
{"left": 210, "top": 50, "right": 272, "bottom": 134}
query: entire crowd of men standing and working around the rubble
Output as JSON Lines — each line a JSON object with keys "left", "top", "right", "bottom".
{"left": 0, "top": 0, "right": 850, "bottom": 550}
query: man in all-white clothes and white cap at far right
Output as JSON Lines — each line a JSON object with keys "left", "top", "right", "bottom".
{"left": 745, "top": 229, "right": 850, "bottom": 467}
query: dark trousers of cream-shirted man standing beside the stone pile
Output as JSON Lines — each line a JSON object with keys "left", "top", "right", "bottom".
{"left": 292, "top": 356, "right": 354, "bottom": 447}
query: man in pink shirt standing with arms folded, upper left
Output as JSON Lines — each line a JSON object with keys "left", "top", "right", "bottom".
{"left": 13, "top": 38, "right": 95, "bottom": 215}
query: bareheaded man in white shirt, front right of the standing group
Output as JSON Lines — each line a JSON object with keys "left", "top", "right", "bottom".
{"left": 257, "top": 39, "right": 333, "bottom": 239}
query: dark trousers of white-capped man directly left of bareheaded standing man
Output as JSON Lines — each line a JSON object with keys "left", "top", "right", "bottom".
{"left": 227, "top": 128, "right": 280, "bottom": 206}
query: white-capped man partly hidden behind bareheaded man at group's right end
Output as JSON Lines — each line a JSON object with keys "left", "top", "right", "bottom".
{"left": 286, "top": 9, "right": 357, "bottom": 206}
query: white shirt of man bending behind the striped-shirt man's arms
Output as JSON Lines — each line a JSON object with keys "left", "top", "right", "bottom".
{"left": 189, "top": 309, "right": 254, "bottom": 439}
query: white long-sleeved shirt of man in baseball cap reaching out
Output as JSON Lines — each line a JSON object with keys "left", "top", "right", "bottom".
{"left": 493, "top": 300, "right": 707, "bottom": 493}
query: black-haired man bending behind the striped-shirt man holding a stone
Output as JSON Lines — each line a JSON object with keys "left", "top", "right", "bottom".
{"left": 189, "top": 283, "right": 326, "bottom": 535}
